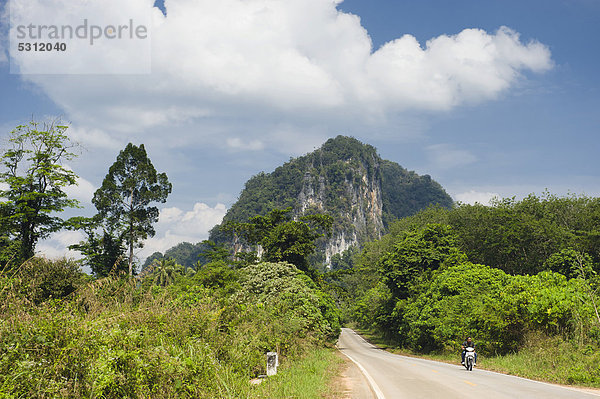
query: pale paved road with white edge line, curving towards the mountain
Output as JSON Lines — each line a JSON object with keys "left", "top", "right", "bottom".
{"left": 338, "top": 328, "right": 600, "bottom": 399}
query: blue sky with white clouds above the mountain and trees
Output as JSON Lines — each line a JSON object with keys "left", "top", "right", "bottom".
{"left": 0, "top": 0, "right": 600, "bottom": 258}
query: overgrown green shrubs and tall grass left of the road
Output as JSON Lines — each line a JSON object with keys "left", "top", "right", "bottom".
{"left": 0, "top": 260, "right": 338, "bottom": 398}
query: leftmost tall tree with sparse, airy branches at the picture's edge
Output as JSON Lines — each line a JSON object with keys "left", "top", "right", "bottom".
{"left": 0, "top": 121, "right": 79, "bottom": 260}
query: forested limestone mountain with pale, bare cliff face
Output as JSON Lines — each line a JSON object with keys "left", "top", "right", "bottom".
{"left": 211, "top": 136, "right": 452, "bottom": 263}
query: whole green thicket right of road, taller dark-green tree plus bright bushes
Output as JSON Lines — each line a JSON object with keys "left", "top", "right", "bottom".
{"left": 352, "top": 217, "right": 600, "bottom": 368}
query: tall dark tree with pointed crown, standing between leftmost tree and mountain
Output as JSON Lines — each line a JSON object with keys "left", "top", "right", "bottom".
{"left": 92, "top": 143, "right": 172, "bottom": 276}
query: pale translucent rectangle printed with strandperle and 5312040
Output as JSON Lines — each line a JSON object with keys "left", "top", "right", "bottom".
{"left": 9, "top": 0, "right": 158, "bottom": 75}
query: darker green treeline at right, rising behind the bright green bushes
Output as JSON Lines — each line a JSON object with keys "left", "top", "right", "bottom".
{"left": 388, "top": 193, "right": 600, "bottom": 274}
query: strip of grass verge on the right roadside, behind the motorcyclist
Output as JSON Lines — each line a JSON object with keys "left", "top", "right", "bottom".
{"left": 354, "top": 328, "right": 600, "bottom": 388}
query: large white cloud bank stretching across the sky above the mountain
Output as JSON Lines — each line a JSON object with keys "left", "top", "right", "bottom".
{"left": 9, "top": 0, "right": 552, "bottom": 141}
